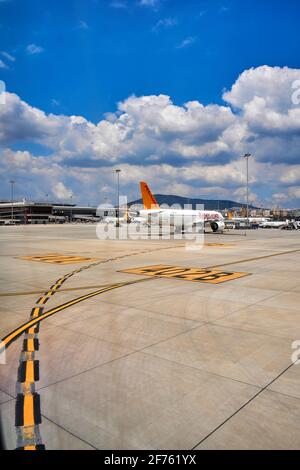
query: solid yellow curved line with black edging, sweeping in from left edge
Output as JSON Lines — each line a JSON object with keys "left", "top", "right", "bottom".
{"left": 0, "top": 278, "right": 149, "bottom": 350}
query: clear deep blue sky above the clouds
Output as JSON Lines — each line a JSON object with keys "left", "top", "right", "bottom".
{"left": 0, "top": 0, "right": 300, "bottom": 122}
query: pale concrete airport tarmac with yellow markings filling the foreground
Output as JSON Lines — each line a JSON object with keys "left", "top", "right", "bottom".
{"left": 0, "top": 224, "right": 300, "bottom": 450}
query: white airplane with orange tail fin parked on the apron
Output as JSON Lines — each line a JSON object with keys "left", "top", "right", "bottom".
{"left": 138, "top": 181, "right": 225, "bottom": 232}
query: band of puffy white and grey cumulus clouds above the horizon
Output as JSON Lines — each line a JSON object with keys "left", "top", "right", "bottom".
{"left": 0, "top": 66, "right": 300, "bottom": 204}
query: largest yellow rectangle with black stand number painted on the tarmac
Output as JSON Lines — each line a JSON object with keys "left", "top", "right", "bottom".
{"left": 121, "top": 264, "right": 249, "bottom": 284}
